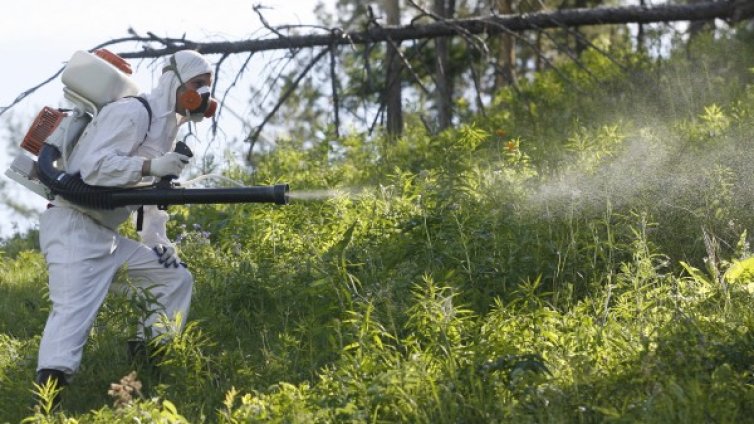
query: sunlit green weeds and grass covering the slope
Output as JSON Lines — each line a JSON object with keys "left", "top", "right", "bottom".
{"left": 0, "top": 33, "right": 754, "bottom": 423}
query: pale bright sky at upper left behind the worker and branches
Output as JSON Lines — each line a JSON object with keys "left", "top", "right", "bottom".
{"left": 0, "top": 0, "right": 332, "bottom": 237}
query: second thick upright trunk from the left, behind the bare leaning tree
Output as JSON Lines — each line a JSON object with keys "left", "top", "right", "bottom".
{"left": 432, "top": 0, "right": 455, "bottom": 131}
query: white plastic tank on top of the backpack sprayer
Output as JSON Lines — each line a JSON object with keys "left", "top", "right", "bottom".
{"left": 62, "top": 50, "right": 139, "bottom": 109}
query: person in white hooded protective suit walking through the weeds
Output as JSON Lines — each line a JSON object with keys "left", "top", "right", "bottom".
{"left": 36, "top": 50, "right": 212, "bottom": 398}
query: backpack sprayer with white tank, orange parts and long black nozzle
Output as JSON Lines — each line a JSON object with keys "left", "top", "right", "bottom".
{"left": 5, "top": 49, "right": 288, "bottom": 209}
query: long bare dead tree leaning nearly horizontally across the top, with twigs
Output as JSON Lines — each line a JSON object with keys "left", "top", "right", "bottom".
{"left": 0, "top": 0, "right": 754, "bottom": 135}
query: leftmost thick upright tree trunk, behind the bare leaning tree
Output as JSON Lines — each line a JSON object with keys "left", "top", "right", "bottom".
{"left": 384, "top": 0, "right": 403, "bottom": 137}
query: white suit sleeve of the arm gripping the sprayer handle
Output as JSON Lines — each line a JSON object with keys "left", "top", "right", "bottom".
{"left": 68, "top": 99, "right": 149, "bottom": 187}
